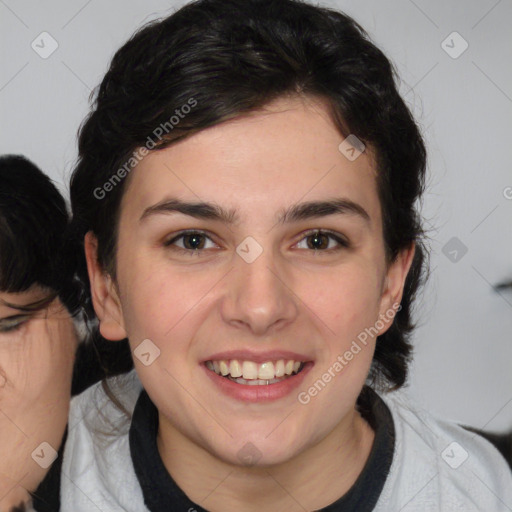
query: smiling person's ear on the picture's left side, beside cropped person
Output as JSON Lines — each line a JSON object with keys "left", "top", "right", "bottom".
{"left": 84, "top": 231, "right": 127, "bottom": 341}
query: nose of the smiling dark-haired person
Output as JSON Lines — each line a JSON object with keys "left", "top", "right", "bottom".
{"left": 221, "top": 247, "right": 298, "bottom": 336}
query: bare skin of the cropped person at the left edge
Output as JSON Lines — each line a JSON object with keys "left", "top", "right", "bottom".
{"left": 0, "top": 286, "right": 77, "bottom": 512}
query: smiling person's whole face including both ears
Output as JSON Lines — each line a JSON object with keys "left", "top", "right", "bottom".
{"left": 86, "top": 95, "right": 412, "bottom": 465}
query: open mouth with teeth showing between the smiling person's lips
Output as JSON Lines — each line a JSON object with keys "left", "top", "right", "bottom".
{"left": 205, "top": 359, "right": 305, "bottom": 386}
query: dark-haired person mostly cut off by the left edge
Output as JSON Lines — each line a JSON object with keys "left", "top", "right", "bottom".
{"left": 0, "top": 156, "right": 77, "bottom": 512}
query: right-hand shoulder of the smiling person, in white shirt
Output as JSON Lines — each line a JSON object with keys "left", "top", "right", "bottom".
{"left": 376, "top": 390, "right": 512, "bottom": 512}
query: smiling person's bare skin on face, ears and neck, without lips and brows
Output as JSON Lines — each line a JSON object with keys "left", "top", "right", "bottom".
{"left": 85, "top": 94, "right": 414, "bottom": 512}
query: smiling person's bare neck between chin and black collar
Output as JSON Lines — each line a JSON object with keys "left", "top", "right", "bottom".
{"left": 157, "top": 410, "right": 374, "bottom": 512}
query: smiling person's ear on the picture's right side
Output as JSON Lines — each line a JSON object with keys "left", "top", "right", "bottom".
{"left": 378, "top": 243, "right": 415, "bottom": 336}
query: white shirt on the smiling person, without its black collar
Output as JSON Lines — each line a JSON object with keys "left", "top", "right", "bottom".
{"left": 61, "top": 371, "right": 512, "bottom": 512}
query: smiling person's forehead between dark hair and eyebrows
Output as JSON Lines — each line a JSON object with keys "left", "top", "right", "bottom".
{"left": 122, "top": 98, "right": 380, "bottom": 224}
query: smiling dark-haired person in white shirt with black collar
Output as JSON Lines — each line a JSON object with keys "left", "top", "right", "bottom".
{"left": 61, "top": 0, "right": 512, "bottom": 512}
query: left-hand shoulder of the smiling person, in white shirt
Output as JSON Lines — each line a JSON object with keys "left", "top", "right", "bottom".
{"left": 61, "top": 371, "right": 146, "bottom": 512}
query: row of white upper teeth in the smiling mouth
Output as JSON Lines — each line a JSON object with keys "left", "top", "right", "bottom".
{"left": 206, "top": 359, "right": 301, "bottom": 380}
